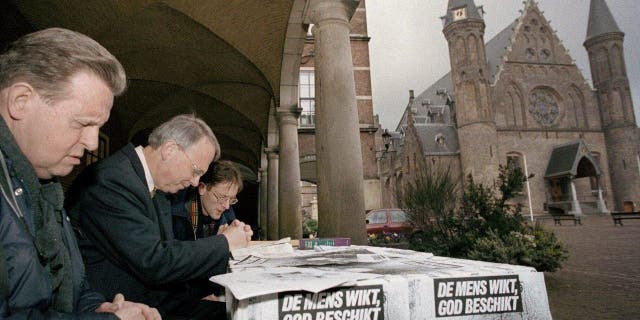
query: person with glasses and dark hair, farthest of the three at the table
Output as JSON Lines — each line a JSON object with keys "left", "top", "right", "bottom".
{"left": 172, "top": 160, "right": 242, "bottom": 240}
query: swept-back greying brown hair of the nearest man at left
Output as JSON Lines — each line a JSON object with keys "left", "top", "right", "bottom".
{"left": 0, "top": 28, "right": 127, "bottom": 102}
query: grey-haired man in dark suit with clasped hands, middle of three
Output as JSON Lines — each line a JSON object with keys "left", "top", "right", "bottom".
{"left": 68, "top": 115, "right": 252, "bottom": 319}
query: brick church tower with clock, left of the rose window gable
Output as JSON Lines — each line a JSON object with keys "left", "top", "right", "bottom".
{"left": 442, "top": 0, "right": 500, "bottom": 186}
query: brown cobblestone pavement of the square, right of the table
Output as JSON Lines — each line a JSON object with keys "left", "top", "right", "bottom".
{"left": 542, "top": 216, "right": 640, "bottom": 320}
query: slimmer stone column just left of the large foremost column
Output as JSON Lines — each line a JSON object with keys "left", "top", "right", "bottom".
{"left": 278, "top": 109, "right": 302, "bottom": 239}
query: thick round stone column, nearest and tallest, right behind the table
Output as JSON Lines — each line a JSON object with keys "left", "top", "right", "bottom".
{"left": 309, "top": 0, "right": 367, "bottom": 245}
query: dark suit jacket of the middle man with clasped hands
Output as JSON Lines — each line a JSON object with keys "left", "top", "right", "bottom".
{"left": 68, "top": 144, "right": 229, "bottom": 309}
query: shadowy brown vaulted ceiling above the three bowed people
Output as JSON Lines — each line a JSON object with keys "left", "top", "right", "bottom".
{"left": 4, "top": 0, "right": 304, "bottom": 171}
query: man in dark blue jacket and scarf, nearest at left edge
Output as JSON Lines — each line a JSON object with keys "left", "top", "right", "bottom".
{"left": 0, "top": 28, "right": 159, "bottom": 319}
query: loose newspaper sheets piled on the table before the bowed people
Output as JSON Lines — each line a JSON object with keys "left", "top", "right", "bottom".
{"left": 216, "top": 238, "right": 433, "bottom": 300}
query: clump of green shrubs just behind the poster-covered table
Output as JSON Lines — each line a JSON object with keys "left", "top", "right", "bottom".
{"left": 398, "top": 166, "right": 567, "bottom": 271}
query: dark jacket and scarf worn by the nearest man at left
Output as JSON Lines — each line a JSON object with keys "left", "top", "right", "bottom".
{"left": 0, "top": 118, "right": 117, "bottom": 319}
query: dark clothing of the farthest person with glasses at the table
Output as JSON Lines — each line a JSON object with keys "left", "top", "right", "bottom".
{"left": 171, "top": 188, "right": 236, "bottom": 240}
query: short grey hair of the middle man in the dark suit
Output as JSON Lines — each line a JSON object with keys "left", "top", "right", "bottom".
{"left": 149, "top": 114, "right": 220, "bottom": 161}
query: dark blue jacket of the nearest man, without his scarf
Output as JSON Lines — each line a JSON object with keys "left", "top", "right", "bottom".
{"left": 0, "top": 154, "right": 117, "bottom": 319}
